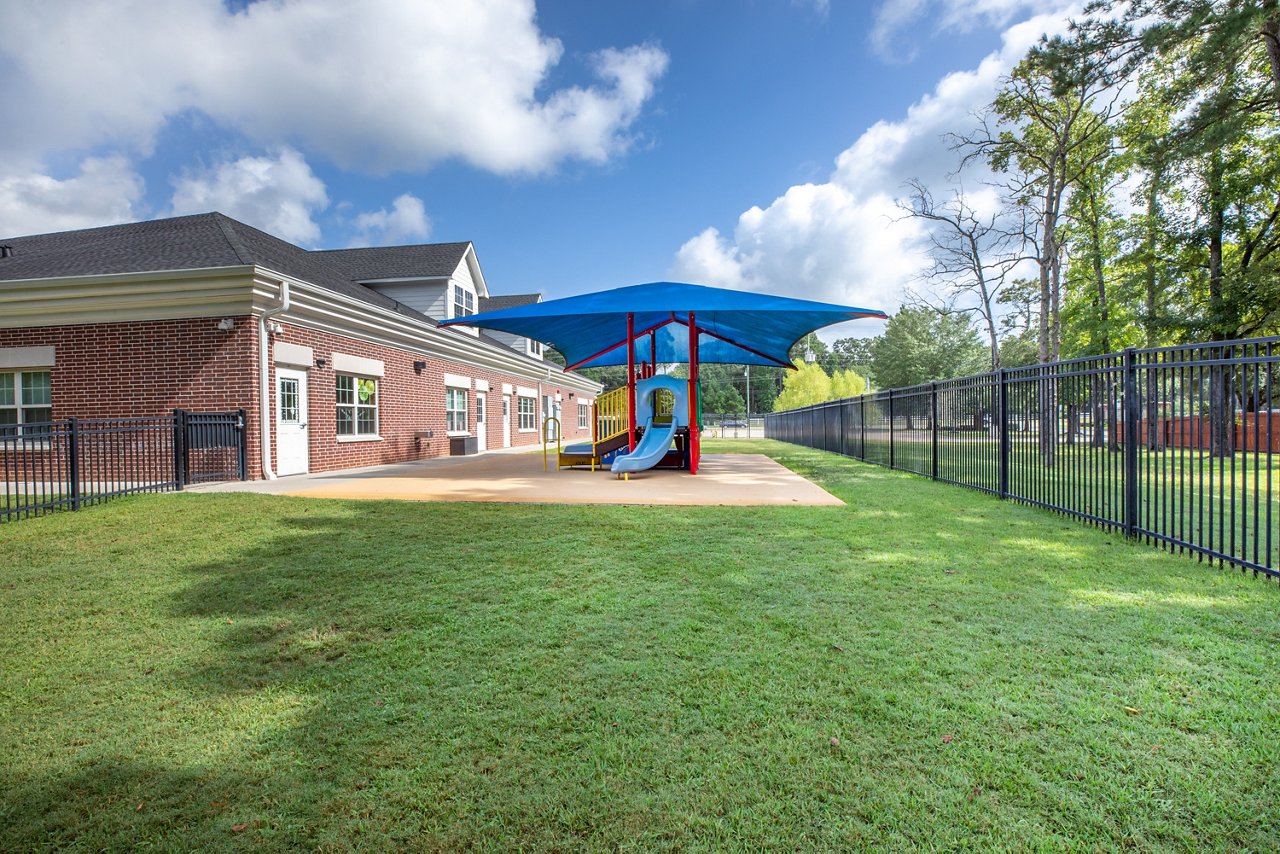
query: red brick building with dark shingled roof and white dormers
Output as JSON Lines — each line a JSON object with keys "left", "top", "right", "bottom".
{"left": 0, "top": 213, "right": 600, "bottom": 478}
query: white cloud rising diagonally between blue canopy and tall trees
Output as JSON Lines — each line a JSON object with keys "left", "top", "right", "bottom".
{"left": 669, "top": 15, "right": 1080, "bottom": 334}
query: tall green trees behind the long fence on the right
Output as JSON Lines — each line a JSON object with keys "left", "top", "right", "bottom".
{"left": 565, "top": 0, "right": 1280, "bottom": 419}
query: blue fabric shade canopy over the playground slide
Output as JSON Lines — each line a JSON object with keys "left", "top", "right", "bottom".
{"left": 440, "top": 282, "right": 886, "bottom": 369}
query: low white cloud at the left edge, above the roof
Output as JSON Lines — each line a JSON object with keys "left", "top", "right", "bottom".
{"left": 0, "top": 155, "right": 143, "bottom": 237}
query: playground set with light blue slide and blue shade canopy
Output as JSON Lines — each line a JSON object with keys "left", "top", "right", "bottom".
{"left": 440, "top": 282, "right": 886, "bottom": 478}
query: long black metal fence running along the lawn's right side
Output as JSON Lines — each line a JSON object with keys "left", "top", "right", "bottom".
{"left": 765, "top": 338, "right": 1280, "bottom": 579}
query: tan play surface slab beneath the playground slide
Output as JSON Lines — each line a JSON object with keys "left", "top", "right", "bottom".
{"left": 271, "top": 453, "right": 844, "bottom": 506}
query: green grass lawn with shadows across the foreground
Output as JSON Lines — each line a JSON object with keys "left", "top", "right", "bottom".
{"left": 0, "top": 440, "right": 1280, "bottom": 850}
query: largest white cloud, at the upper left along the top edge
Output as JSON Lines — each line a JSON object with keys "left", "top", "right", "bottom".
{"left": 0, "top": 0, "right": 667, "bottom": 173}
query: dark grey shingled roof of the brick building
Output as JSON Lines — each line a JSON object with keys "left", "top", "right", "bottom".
{"left": 0, "top": 213, "right": 488, "bottom": 324}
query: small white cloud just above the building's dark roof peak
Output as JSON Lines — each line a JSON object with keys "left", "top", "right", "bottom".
{"left": 173, "top": 149, "right": 329, "bottom": 245}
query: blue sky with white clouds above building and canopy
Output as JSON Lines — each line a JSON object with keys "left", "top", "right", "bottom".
{"left": 0, "top": 0, "right": 1068, "bottom": 334}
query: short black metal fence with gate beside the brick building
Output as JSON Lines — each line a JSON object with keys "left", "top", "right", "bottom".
{"left": 0, "top": 410, "right": 248, "bottom": 522}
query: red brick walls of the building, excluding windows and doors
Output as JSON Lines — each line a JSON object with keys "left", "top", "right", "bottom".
{"left": 0, "top": 316, "right": 591, "bottom": 479}
